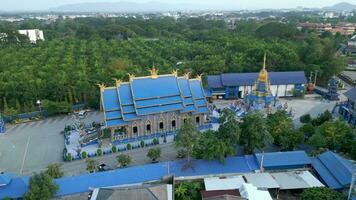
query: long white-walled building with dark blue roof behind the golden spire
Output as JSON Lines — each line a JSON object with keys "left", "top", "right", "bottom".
{"left": 207, "top": 71, "right": 307, "bottom": 98}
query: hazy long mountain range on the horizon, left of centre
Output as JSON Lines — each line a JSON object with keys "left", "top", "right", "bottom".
{"left": 50, "top": 1, "right": 232, "bottom": 12}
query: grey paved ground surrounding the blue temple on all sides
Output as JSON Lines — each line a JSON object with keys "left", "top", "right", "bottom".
{"left": 0, "top": 95, "right": 335, "bottom": 176}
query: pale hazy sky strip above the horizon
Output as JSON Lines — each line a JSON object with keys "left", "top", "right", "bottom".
{"left": 0, "top": 0, "right": 356, "bottom": 11}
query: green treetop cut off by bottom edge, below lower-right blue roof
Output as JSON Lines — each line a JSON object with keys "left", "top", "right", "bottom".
{"left": 300, "top": 187, "right": 346, "bottom": 200}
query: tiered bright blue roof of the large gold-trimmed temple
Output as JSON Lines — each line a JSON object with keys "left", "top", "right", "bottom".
{"left": 101, "top": 75, "right": 209, "bottom": 126}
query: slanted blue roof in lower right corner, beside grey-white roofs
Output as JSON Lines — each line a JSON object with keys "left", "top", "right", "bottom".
{"left": 312, "top": 151, "right": 353, "bottom": 189}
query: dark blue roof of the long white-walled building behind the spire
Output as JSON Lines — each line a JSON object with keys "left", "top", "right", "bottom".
{"left": 207, "top": 71, "right": 307, "bottom": 88}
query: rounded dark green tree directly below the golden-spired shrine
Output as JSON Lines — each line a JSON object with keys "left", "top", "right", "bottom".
{"left": 240, "top": 112, "right": 273, "bottom": 153}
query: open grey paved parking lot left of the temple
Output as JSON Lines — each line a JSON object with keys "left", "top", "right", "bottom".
{"left": 0, "top": 112, "right": 103, "bottom": 175}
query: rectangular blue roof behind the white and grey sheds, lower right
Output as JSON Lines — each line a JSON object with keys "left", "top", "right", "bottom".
{"left": 255, "top": 151, "right": 311, "bottom": 169}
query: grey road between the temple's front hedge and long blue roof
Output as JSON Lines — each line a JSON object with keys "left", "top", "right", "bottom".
{"left": 62, "top": 142, "right": 176, "bottom": 176}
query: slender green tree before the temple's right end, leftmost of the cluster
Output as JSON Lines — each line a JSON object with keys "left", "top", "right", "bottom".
{"left": 175, "top": 118, "right": 199, "bottom": 165}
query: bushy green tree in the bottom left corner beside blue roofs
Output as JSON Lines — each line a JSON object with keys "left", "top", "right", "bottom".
{"left": 23, "top": 172, "right": 58, "bottom": 200}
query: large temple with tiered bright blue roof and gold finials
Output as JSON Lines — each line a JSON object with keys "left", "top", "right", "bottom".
{"left": 99, "top": 68, "right": 209, "bottom": 142}
